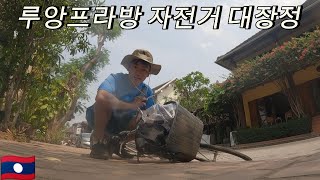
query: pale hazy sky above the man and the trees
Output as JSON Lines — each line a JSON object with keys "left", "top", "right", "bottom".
{"left": 71, "top": 0, "right": 305, "bottom": 123}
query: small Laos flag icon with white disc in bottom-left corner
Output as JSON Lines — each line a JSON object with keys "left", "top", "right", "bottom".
{"left": 1, "top": 156, "right": 36, "bottom": 180}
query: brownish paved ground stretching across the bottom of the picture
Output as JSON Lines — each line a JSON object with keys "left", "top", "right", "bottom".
{"left": 0, "top": 137, "right": 320, "bottom": 180}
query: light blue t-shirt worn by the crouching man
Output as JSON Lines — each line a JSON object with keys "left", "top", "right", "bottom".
{"left": 98, "top": 73, "right": 155, "bottom": 110}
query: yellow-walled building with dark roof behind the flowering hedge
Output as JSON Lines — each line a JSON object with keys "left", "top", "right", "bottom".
{"left": 216, "top": 0, "right": 320, "bottom": 133}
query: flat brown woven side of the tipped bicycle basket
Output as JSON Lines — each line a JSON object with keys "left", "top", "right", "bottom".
{"left": 166, "top": 101, "right": 203, "bottom": 162}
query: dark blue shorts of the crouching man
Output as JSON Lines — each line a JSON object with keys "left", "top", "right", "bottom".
{"left": 86, "top": 105, "right": 137, "bottom": 134}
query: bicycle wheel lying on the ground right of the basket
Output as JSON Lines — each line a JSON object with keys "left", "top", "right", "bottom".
{"left": 196, "top": 143, "right": 252, "bottom": 161}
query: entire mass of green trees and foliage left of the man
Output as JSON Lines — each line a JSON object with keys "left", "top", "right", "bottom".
{"left": 0, "top": 0, "right": 121, "bottom": 141}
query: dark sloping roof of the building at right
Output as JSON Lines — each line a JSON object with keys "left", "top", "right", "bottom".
{"left": 216, "top": 0, "right": 320, "bottom": 70}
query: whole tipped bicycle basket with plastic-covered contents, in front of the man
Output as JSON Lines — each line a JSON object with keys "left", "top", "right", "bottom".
{"left": 135, "top": 101, "right": 203, "bottom": 162}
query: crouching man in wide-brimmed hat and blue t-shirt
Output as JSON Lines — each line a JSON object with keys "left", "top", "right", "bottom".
{"left": 86, "top": 49, "right": 161, "bottom": 159}
